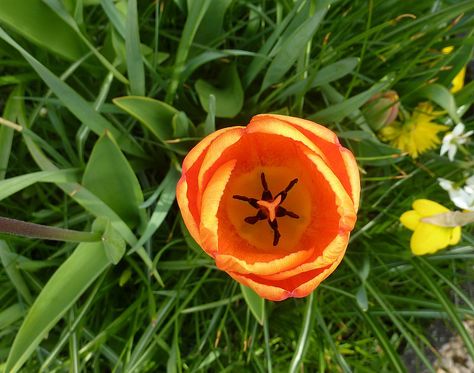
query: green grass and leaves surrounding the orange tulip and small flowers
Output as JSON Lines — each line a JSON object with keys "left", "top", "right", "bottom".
{"left": 0, "top": 0, "right": 474, "bottom": 372}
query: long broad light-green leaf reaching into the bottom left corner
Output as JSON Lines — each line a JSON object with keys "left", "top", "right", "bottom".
{"left": 5, "top": 242, "right": 111, "bottom": 373}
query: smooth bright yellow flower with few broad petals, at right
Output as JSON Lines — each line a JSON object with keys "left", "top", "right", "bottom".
{"left": 400, "top": 199, "right": 461, "bottom": 255}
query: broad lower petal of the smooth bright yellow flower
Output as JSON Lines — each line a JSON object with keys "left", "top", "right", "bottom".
{"left": 410, "top": 223, "right": 453, "bottom": 255}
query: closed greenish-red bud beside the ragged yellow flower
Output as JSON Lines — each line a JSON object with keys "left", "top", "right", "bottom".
{"left": 362, "top": 91, "right": 400, "bottom": 131}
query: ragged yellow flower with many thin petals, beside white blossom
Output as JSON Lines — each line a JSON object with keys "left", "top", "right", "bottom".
{"left": 379, "top": 102, "right": 448, "bottom": 158}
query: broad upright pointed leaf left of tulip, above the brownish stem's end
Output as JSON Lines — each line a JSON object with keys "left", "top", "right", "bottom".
{"left": 82, "top": 132, "right": 143, "bottom": 226}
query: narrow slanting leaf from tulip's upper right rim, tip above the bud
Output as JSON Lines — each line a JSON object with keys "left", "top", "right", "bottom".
{"left": 308, "top": 79, "right": 390, "bottom": 123}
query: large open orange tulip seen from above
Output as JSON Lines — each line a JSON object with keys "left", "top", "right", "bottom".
{"left": 177, "top": 114, "right": 360, "bottom": 301}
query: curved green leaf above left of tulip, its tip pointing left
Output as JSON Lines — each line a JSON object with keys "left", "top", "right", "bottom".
{"left": 113, "top": 96, "right": 178, "bottom": 141}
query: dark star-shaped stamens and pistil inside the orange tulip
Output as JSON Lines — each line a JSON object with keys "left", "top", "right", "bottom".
{"left": 232, "top": 172, "right": 299, "bottom": 246}
